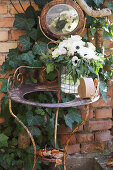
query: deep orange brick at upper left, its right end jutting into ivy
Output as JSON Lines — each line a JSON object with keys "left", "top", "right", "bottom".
{"left": 11, "top": 30, "right": 26, "bottom": 40}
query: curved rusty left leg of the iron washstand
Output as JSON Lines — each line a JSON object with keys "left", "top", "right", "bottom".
{"left": 9, "top": 99, "right": 36, "bottom": 170}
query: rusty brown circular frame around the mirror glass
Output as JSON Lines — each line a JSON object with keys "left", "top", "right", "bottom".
{"left": 40, "top": 0, "right": 85, "bottom": 38}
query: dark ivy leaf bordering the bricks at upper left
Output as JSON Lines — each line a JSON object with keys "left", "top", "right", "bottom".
{"left": 19, "top": 35, "right": 32, "bottom": 50}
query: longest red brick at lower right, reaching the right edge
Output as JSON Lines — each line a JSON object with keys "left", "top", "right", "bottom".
{"left": 84, "top": 119, "right": 112, "bottom": 131}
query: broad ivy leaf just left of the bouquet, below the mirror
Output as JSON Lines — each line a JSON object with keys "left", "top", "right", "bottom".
{"left": 32, "top": 42, "right": 47, "bottom": 55}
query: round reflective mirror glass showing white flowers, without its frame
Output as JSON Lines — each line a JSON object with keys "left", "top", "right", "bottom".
{"left": 46, "top": 4, "right": 79, "bottom": 34}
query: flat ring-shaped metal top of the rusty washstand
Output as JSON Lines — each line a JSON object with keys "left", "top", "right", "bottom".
{"left": 8, "top": 84, "right": 99, "bottom": 108}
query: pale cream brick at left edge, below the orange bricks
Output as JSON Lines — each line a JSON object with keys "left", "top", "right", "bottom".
{"left": 0, "top": 42, "right": 17, "bottom": 53}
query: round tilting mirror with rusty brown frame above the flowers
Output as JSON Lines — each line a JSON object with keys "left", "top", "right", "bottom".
{"left": 40, "top": 0, "right": 85, "bottom": 38}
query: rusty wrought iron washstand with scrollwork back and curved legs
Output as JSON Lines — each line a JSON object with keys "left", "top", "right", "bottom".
{"left": 7, "top": 66, "right": 99, "bottom": 170}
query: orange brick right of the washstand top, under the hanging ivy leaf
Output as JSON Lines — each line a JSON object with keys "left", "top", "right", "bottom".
{"left": 90, "top": 97, "right": 111, "bottom": 107}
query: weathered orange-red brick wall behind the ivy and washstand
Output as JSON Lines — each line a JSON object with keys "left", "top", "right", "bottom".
{"left": 0, "top": 0, "right": 113, "bottom": 153}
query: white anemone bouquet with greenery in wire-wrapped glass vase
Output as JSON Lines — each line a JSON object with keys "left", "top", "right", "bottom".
{"left": 46, "top": 35, "right": 104, "bottom": 93}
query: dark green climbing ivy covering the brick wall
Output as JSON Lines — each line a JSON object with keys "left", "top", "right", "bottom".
{"left": 0, "top": 0, "right": 113, "bottom": 170}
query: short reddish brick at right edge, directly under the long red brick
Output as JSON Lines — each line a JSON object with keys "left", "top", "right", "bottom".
{"left": 95, "top": 130, "right": 111, "bottom": 142}
